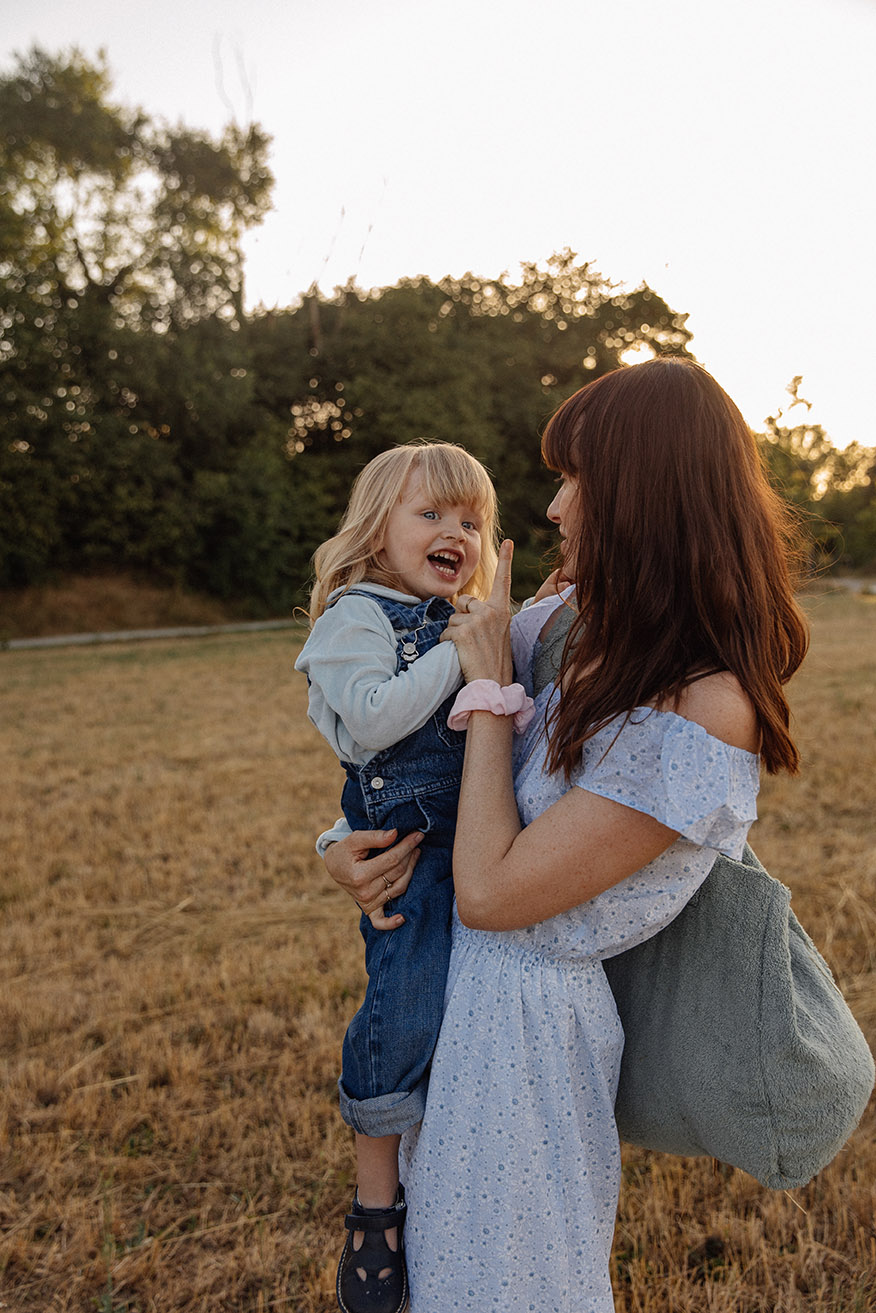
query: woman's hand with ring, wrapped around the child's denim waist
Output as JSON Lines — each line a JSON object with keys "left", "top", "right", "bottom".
{"left": 323, "top": 830, "right": 423, "bottom": 930}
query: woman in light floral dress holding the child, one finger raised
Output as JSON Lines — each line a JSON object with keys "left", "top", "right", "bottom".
{"left": 321, "top": 358, "right": 806, "bottom": 1313}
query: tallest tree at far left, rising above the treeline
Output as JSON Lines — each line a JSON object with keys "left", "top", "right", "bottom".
{"left": 0, "top": 50, "right": 272, "bottom": 583}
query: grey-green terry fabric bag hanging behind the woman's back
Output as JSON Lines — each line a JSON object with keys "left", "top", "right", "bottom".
{"left": 532, "top": 607, "right": 873, "bottom": 1190}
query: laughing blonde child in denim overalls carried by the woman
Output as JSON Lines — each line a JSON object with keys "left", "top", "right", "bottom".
{"left": 296, "top": 442, "right": 498, "bottom": 1313}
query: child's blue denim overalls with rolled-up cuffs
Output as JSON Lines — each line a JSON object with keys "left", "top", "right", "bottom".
{"left": 338, "top": 588, "right": 465, "bottom": 1136}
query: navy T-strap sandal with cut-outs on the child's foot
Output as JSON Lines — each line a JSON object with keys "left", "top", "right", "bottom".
{"left": 338, "top": 1186, "right": 407, "bottom": 1313}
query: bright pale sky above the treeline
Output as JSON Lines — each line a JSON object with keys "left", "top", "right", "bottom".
{"left": 0, "top": 0, "right": 876, "bottom": 446}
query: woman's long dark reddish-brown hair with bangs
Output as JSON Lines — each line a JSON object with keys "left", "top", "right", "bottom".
{"left": 541, "top": 357, "right": 808, "bottom": 775}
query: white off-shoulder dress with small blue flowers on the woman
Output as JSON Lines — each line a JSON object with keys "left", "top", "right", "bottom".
{"left": 402, "top": 596, "right": 759, "bottom": 1313}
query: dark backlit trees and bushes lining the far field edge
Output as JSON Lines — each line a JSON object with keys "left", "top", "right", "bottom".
{"left": 0, "top": 49, "right": 876, "bottom": 614}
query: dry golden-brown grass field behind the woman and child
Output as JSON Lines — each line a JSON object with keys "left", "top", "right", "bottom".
{"left": 0, "top": 593, "right": 876, "bottom": 1313}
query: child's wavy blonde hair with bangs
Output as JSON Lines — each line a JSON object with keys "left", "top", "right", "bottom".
{"left": 310, "top": 441, "right": 499, "bottom": 625}
